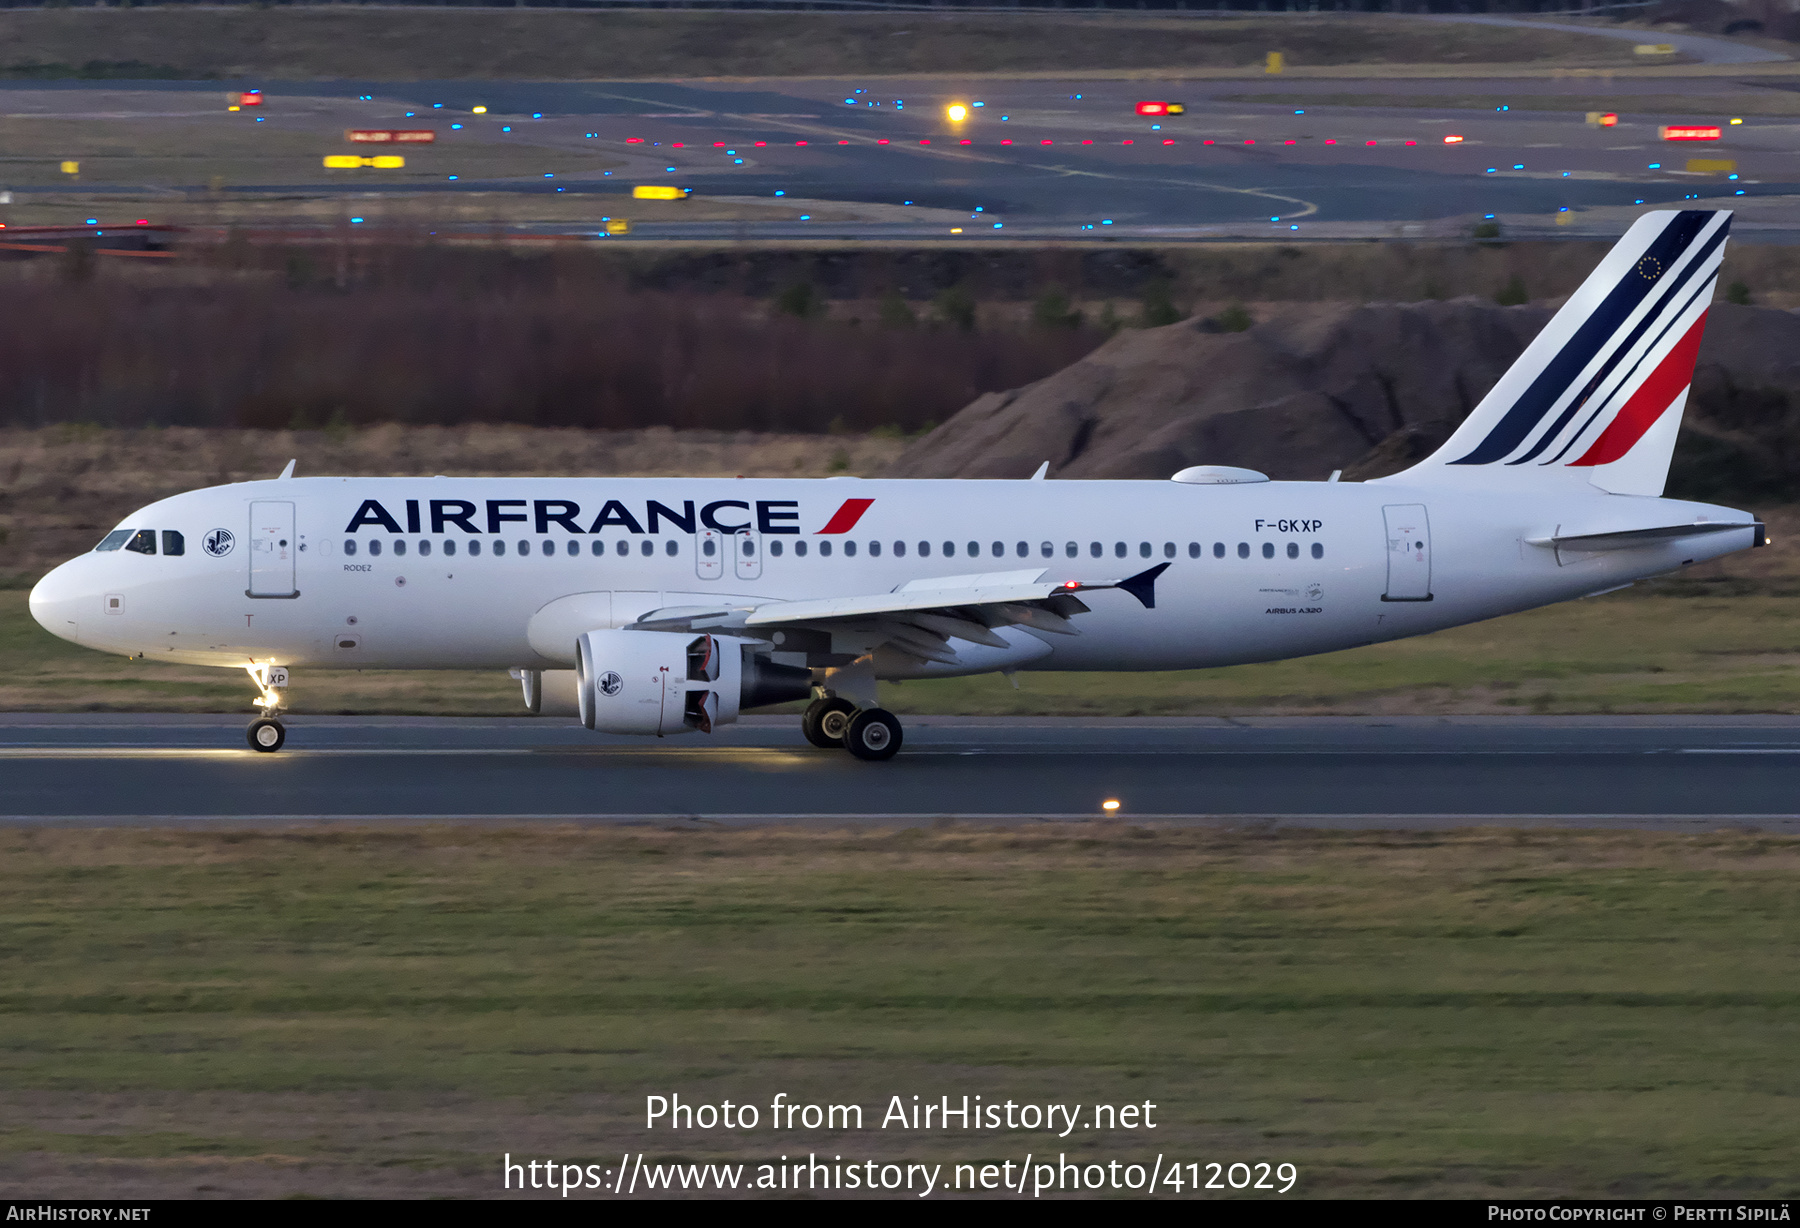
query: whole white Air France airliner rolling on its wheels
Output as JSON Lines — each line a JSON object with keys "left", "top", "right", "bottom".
{"left": 31, "top": 211, "right": 1764, "bottom": 760}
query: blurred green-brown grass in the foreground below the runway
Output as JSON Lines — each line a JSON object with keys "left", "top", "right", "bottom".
{"left": 0, "top": 826, "right": 1800, "bottom": 1197}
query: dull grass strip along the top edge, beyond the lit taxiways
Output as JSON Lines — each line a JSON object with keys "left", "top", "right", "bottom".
{"left": 0, "top": 5, "right": 1633, "bottom": 81}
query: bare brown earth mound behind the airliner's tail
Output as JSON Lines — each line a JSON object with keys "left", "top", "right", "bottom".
{"left": 887, "top": 299, "right": 1800, "bottom": 501}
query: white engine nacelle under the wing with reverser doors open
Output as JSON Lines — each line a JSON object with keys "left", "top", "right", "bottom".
{"left": 576, "top": 630, "right": 812, "bottom": 736}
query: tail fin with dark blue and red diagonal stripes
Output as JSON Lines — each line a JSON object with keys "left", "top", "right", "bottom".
{"left": 1391, "top": 209, "right": 1732, "bottom": 495}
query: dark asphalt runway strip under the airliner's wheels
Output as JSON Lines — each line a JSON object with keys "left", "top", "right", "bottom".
{"left": 10, "top": 713, "right": 1800, "bottom": 834}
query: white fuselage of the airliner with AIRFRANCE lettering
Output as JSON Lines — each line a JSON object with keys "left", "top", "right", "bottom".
{"left": 31, "top": 477, "right": 1753, "bottom": 677}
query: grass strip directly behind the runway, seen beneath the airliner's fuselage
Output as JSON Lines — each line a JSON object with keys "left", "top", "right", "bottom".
{"left": 10, "top": 591, "right": 1800, "bottom": 717}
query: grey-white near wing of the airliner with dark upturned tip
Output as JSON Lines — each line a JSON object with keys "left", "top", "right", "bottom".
{"left": 632, "top": 564, "right": 1168, "bottom": 664}
